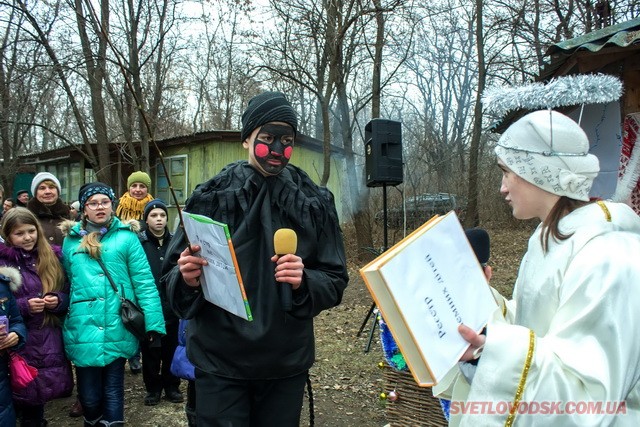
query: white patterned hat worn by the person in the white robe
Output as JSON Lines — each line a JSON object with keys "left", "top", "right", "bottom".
{"left": 495, "top": 110, "right": 600, "bottom": 201}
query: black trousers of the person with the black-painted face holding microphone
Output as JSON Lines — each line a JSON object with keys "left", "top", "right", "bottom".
{"left": 196, "top": 368, "right": 309, "bottom": 427}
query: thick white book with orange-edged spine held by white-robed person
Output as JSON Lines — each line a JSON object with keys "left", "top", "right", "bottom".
{"left": 360, "top": 211, "right": 497, "bottom": 387}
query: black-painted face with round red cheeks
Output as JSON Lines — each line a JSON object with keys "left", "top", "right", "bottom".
{"left": 253, "top": 123, "right": 294, "bottom": 175}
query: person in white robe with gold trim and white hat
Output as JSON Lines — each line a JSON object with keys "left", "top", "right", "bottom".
{"left": 433, "top": 110, "right": 640, "bottom": 427}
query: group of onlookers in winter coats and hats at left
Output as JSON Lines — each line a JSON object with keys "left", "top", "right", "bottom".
{"left": 0, "top": 171, "right": 195, "bottom": 427}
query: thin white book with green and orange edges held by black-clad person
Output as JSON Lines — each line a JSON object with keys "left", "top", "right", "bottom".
{"left": 182, "top": 211, "right": 253, "bottom": 321}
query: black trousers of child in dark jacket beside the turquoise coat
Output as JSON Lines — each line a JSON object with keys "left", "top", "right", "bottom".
{"left": 140, "top": 321, "right": 180, "bottom": 393}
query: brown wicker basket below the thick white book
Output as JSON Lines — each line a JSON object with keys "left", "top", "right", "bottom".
{"left": 383, "top": 364, "right": 447, "bottom": 427}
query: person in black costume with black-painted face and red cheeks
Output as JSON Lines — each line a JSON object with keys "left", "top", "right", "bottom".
{"left": 163, "top": 92, "right": 348, "bottom": 426}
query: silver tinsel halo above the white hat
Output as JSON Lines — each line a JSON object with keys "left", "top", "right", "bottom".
{"left": 482, "top": 74, "right": 622, "bottom": 115}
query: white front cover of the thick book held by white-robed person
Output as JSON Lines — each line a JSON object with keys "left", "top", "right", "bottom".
{"left": 379, "top": 214, "right": 496, "bottom": 382}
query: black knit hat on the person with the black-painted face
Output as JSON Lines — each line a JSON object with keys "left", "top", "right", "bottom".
{"left": 240, "top": 92, "right": 298, "bottom": 141}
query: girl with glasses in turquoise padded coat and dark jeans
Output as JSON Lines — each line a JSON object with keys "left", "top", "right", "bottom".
{"left": 62, "top": 182, "right": 165, "bottom": 426}
